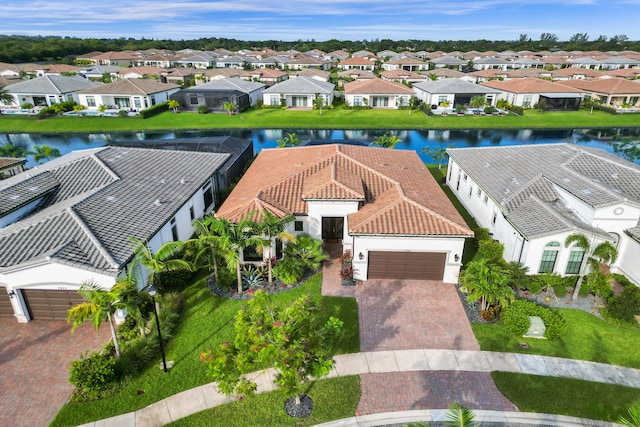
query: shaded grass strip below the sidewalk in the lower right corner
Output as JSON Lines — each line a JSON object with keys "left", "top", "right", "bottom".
{"left": 491, "top": 372, "right": 640, "bottom": 422}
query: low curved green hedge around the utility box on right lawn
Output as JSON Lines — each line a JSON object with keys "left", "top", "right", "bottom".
{"left": 502, "top": 300, "right": 567, "bottom": 340}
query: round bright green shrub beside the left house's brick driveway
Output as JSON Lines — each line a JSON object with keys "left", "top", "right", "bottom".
{"left": 69, "top": 351, "right": 116, "bottom": 398}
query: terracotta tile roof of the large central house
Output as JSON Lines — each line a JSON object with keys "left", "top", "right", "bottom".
{"left": 216, "top": 144, "right": 473, "bottom": 236}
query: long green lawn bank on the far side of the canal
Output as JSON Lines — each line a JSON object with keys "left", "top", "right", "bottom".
{"left": 0, "top": 105, "right": 638, "bottom": 133}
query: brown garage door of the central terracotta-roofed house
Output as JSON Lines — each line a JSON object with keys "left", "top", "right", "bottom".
{"left": 367, "top": 251, "right": 447, "bottom": 280}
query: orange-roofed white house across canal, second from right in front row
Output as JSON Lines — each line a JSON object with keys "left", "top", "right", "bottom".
{"left": 482, "top": 79, "right": 584, "bottom": 110}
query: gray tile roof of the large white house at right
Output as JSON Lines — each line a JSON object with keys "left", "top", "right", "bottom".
{"left": 447, "top": 144, "right": 640, "bottom": 237}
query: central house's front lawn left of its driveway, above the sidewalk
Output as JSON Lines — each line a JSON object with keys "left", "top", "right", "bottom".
{"left": 52, "top": 274, "right": 360, "bottom": 426}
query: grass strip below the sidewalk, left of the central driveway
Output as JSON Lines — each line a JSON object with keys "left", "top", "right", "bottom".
{"left": 167, "top": 375, "right": 360, "bottom": 427}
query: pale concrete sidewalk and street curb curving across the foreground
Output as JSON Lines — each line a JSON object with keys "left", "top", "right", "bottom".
{"left": 83, "top": 349, "right": 640, "bottom": 427}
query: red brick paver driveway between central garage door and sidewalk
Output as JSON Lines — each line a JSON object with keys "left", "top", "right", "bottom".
{"left": 357, "top": 280, "right": 480, "bottom": 351}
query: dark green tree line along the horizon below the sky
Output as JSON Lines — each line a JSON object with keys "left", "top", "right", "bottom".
{"left": 0, "top": 33, "right": 640, "bottom": 64}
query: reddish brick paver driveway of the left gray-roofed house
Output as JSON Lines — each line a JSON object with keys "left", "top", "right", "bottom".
{"left": 0, "top": 317, "right": 110, "bottom": 427}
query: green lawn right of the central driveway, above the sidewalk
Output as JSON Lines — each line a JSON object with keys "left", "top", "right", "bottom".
{"left": 471, "top": 309, "right": 640, "bottom": 369}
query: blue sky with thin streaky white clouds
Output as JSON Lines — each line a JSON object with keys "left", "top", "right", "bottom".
{"left": 0, "top": 0, "right": 640, "bottom": 41}
